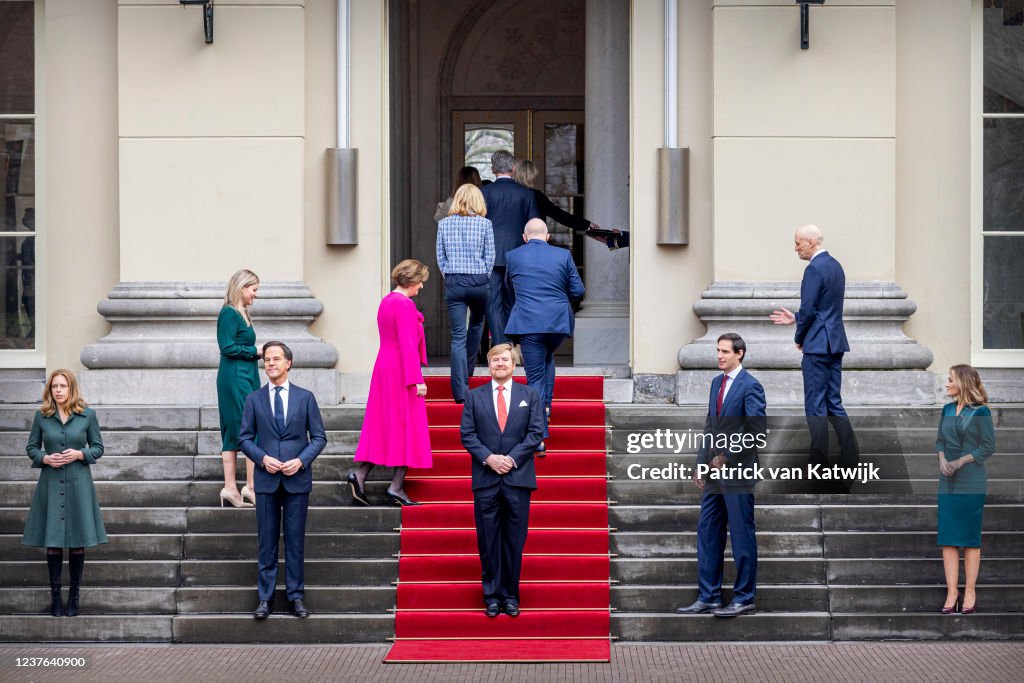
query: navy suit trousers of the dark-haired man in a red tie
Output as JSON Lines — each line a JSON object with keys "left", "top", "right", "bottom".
{"left": 697, "top": 485, "right": 758, "bottom": 603}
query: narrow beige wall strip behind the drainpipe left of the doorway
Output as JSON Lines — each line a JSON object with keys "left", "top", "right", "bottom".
{"left": 304, "top": 0, "right": 390, "bottom": 374}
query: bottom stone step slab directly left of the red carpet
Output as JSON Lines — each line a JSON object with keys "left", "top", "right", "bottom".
{"left": 173, "top": 614, "right": 394, "bottom": 645}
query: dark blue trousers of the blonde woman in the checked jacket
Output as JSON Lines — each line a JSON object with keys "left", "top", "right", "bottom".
{"left": 444, "top": 272, "right": 490, "bottom": 401}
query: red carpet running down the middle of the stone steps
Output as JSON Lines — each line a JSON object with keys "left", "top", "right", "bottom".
{"left": 384, "top": 376, "right": 611, "bottom": 663}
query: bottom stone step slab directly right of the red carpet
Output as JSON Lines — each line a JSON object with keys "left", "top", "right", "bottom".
{"left": 611, "top": 611, "right": 830, "bottom": 642}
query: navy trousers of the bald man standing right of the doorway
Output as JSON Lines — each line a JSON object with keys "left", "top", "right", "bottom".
{"left": 801, "top": 353, "right": 860, "bottom": 467}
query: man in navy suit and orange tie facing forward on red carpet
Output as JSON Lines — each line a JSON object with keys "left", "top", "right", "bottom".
{"left": 461, "top": 344, "right": 544, "bottom": 617}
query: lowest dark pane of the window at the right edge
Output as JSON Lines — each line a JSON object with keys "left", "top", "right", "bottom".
{"left": 984, "top": 237, "right": 1024, "bottom": 349}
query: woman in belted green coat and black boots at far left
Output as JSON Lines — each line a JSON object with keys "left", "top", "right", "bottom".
{"left": 22, "top": 370, "right": 106, "bottom": 616}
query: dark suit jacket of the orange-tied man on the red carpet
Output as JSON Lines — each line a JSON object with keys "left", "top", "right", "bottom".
{"left": 461, "top": 382, "right": 544, "bottom": 490}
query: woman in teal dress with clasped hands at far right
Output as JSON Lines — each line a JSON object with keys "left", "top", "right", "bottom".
{"left": 935, "top": 366, "right": 995, "bottom": 614}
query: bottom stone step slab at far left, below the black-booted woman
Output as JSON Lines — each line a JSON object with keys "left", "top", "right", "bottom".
{"left": 0, "top": 613, "right": 172, "bottom": 643}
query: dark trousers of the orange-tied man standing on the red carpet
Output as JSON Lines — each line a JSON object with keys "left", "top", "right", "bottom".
{"left": 473, "top": 480, "right": 534, "bottom": 604}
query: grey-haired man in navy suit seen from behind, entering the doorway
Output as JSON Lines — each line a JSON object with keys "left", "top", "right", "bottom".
{"left": 482, "top": 150, "right": 541, "bottom": 345}
